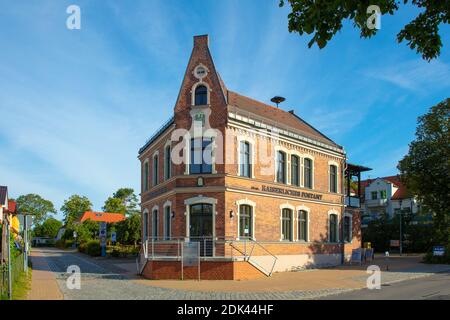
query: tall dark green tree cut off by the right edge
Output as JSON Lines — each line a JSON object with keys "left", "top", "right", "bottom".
{"left": 398, "top": 99, "right": 450, "bottom": 245}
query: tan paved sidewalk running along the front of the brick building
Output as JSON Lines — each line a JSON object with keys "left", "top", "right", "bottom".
{"left": 135, "top": 256, "right": 450, "bottom": 293}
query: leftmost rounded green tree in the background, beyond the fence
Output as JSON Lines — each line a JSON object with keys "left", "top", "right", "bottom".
{"left": 16, "top": 194, "right": 56, "bottom": 225}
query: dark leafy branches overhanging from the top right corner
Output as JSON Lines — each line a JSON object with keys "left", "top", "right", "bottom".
{"left": 279, "top": 0, "right": 450, "bottom": 60}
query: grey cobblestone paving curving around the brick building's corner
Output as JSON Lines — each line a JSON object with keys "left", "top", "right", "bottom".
{"left": 34, "top": 249, "right": 449, "bottom": 300}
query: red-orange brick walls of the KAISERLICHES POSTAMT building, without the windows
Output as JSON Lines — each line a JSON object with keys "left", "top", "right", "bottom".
{"left": 139, "top": 36, "right": 361, "bottom": 279}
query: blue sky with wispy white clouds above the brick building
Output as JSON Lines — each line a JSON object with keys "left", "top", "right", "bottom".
{"left": 0, "top": 0, "right": 450, "bottom": 217}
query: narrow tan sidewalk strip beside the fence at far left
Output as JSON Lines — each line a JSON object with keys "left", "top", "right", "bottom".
{"left": 28, "top": 251, "right": 64, "bottom": 300}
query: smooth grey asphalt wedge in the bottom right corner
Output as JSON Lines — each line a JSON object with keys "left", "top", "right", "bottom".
{"left": 322, "top": 272, "right": 450, "bottom": 300}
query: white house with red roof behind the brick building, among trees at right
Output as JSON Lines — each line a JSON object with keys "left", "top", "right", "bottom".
{"left": 361, "top": 176, "right": 420, "bottom": 222}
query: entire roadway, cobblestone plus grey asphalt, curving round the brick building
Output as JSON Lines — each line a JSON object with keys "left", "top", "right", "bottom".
{"left": 29, "top": 248, "right": 450, "bottom": 300}
